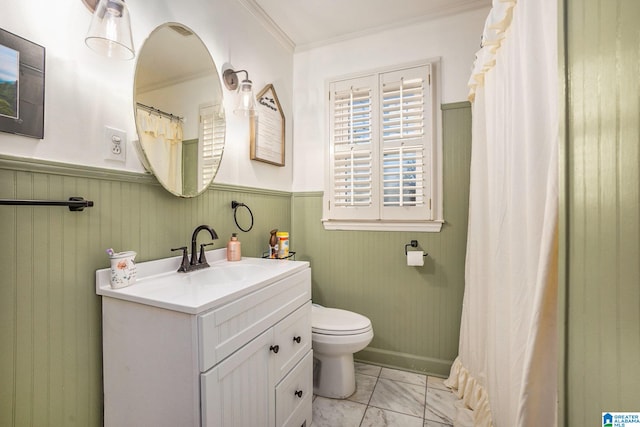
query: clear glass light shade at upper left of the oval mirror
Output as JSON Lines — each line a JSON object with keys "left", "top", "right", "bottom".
{"left": 85, "top": 0, "right": 135, "bottom": 59}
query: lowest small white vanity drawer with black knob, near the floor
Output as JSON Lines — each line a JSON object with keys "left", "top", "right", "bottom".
{"left": 276, "top": 350, "right": 313, "bottom": 427}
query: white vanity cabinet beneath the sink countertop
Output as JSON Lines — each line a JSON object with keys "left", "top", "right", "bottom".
{"left": 99, "top": 254, "right": 313, "bottom": 427}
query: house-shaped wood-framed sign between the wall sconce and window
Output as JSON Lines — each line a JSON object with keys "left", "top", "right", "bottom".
{"left": 250, "top": 84, "right": 284, "bottom": 166}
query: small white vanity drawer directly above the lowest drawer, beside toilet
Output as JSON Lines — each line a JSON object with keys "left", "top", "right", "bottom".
{"left": 273, "top": 301, "right": 311, "bottom": 382}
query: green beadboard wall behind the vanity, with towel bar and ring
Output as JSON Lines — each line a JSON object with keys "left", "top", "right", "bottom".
{"left": 0, "top": 157, "right": 291, "bottom": 427}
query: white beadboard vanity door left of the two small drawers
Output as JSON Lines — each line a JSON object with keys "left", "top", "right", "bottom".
{"left": 200, "top": 329, "right": 275, "bottom": 427}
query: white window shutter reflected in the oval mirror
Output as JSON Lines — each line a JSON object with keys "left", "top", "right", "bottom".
{"left": 198, "top": 105, "right": 225, "bottom": 187}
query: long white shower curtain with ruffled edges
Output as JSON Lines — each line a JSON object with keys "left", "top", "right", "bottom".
{"left": 446, "top": 0, "right": 558, "bottom": 427}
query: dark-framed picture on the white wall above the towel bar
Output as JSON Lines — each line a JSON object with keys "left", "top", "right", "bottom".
{"left": 0, "top": 29, "right": 45, "bottom": 139}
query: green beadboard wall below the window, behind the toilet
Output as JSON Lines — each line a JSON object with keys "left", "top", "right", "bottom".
{"left": 291, "top": 102, "right": 471, "bottom": 375}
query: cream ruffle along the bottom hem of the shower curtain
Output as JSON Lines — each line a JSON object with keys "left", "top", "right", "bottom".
{"left": 444, "top": 357, "right": 493, "bottom": 427}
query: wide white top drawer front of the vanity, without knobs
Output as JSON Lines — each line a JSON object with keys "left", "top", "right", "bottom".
{"left": 198, "top": 268, "right": 311, "bottom": 372}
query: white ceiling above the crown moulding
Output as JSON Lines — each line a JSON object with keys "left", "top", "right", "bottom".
{"left": 245, "top": 0, "right": 491, "bottom": 49}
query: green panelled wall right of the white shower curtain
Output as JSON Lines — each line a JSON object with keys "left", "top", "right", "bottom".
{"left": 560, "top": 0, "right": 640, "bottom": 427}
